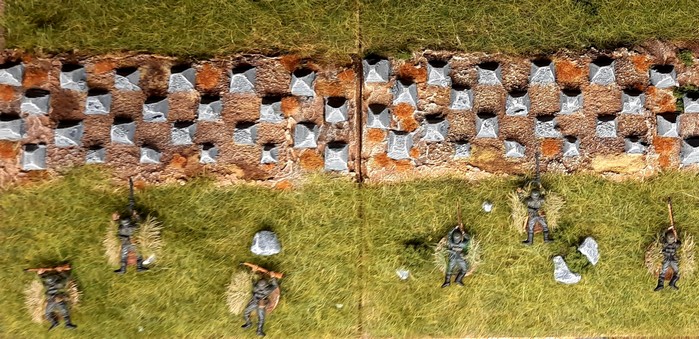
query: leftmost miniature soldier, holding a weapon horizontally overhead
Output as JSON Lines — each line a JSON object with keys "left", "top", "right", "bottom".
{"left": 25, "top": 264, "right": 78, "bottom": 330}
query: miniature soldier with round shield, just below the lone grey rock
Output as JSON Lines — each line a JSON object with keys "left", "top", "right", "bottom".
{"left": 241, "top": 263, "right": 284, "bottom": 337}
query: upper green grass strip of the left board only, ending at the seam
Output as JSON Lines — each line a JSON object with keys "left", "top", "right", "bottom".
{"left": 3, "top": 0, "right": 357, "bottom": 61}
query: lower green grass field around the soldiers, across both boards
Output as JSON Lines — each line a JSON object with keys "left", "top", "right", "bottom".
{"left": 0, "top": 168, "right": 699, "bottom": 338}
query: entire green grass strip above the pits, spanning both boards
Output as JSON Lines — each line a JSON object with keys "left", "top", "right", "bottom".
{"left": 2, "top": 0, "right": 699, "bottom": 62}
